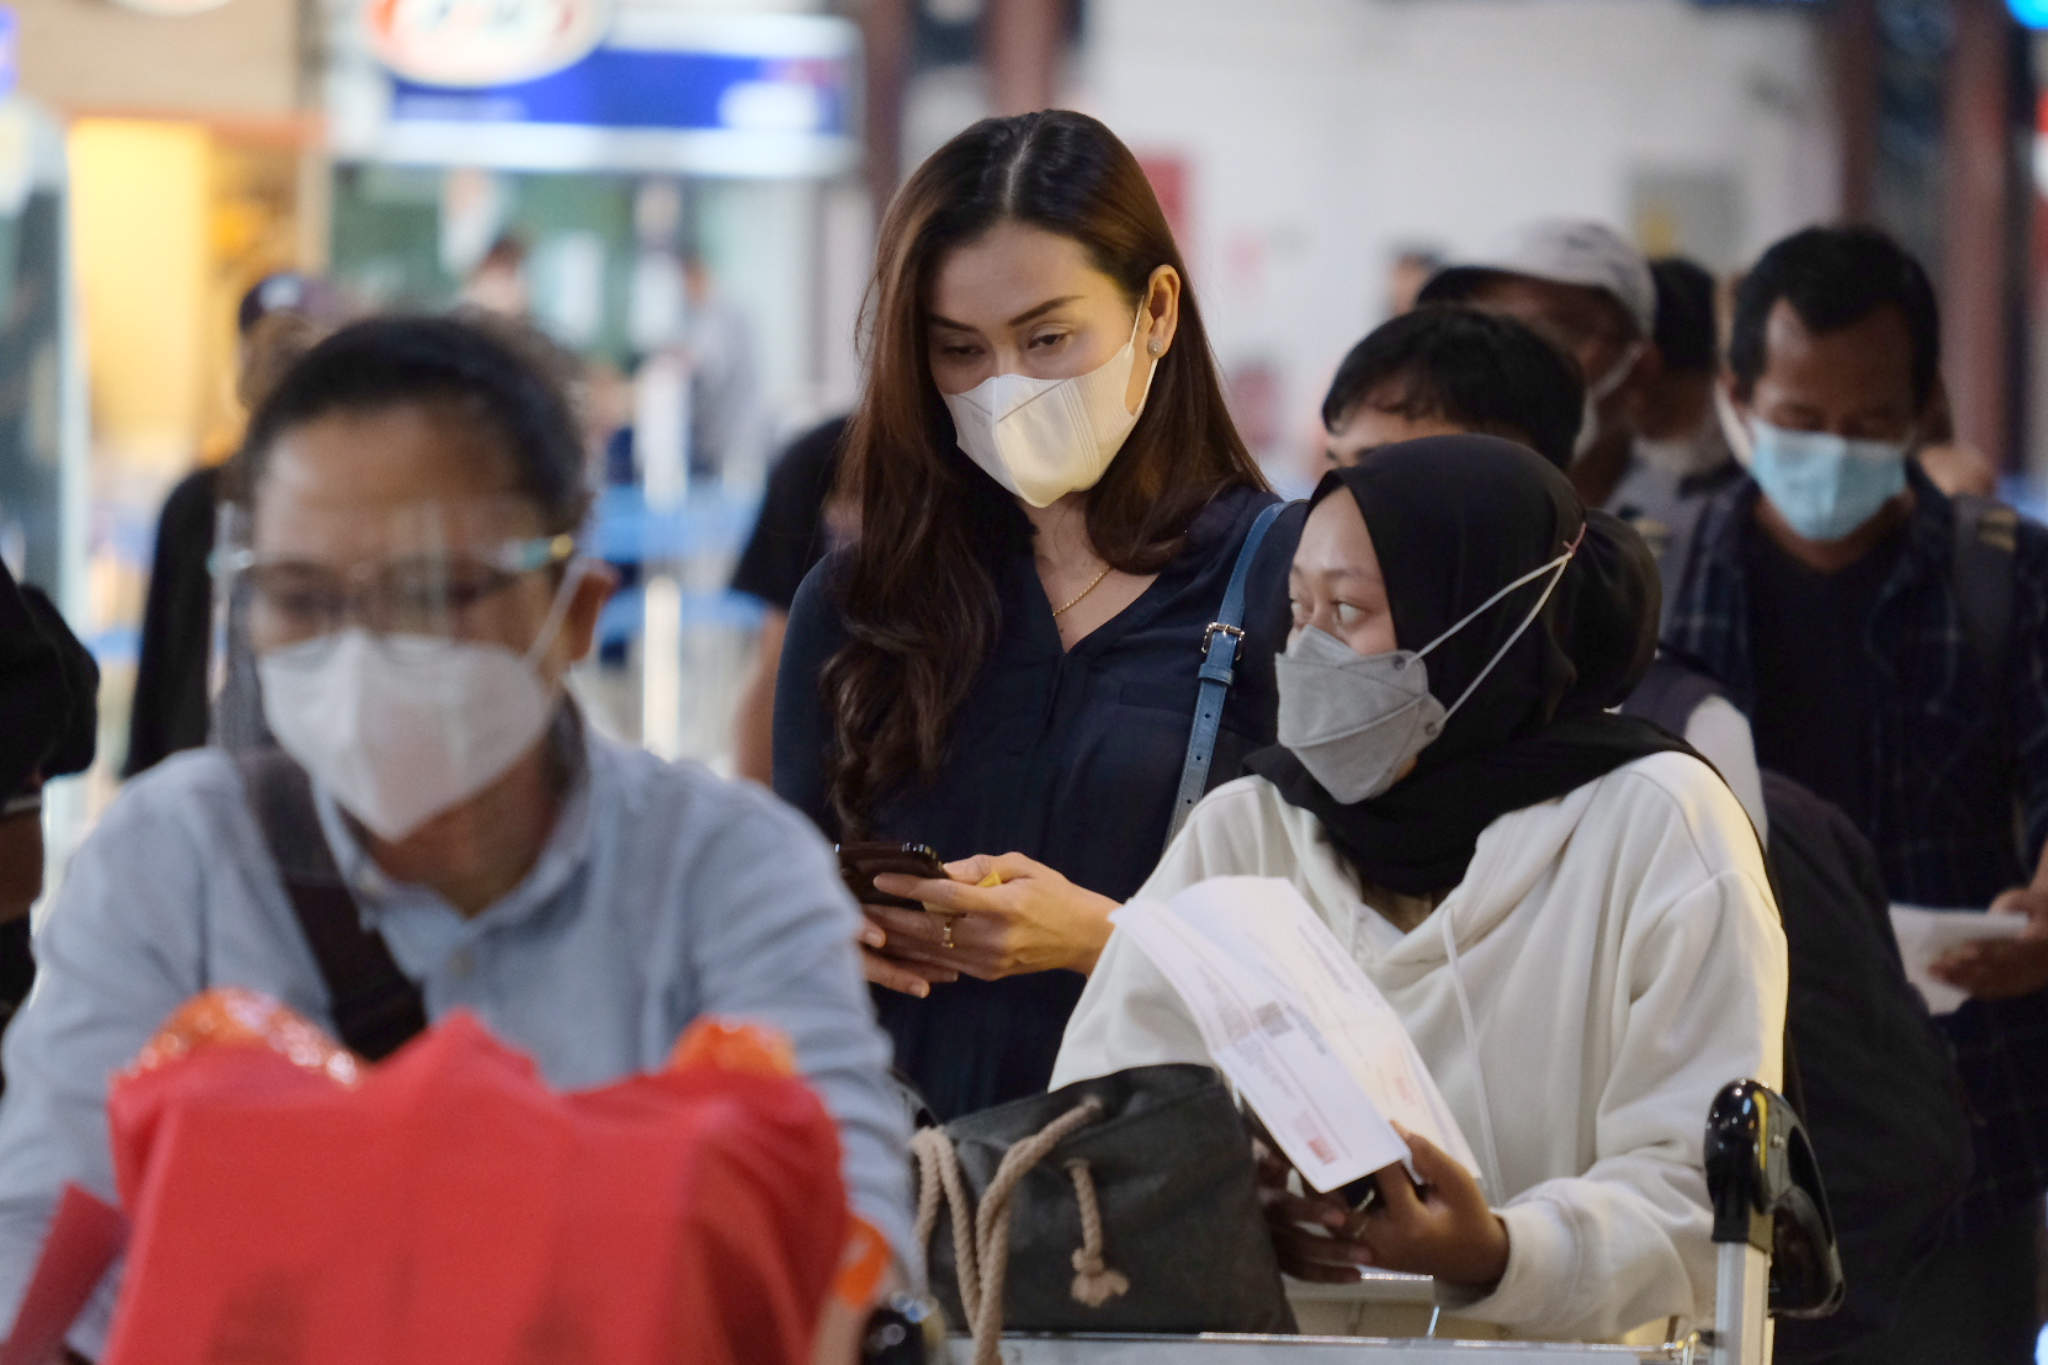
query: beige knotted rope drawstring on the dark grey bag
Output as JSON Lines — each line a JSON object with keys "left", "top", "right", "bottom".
{"left": 909, "top": 1099, "right": 1130, "bottom": 1365}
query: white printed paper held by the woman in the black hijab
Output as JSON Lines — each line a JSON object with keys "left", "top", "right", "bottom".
{"left": 1114, "top": 876, "right": 1479, "bottom": 1191}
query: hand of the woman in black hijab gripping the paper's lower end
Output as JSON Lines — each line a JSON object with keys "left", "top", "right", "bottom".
{"left": 1348, "top": 1126, "right": 1507, "bottom": 1289}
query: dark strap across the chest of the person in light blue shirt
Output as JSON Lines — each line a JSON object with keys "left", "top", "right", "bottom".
{"left": 240, "top": 753, "right": 426, "bottom": 1062}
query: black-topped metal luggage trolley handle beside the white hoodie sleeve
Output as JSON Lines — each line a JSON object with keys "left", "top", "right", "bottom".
{"left": 1706, "top": 1081, "right": 1843, "bottom": 1365}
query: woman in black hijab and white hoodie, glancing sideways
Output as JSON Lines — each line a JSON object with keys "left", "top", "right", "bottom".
{"left": 1053, "top": 436, "right": 1786, "bottom": 1340}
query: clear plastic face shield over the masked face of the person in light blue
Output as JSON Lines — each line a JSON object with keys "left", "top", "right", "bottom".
{"left": 213, "top": 495, "right": 584, "bottom": 862}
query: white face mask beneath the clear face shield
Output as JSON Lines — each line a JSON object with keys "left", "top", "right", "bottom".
{"left": 256, "top": 563, "right": 582, "bottom": 843}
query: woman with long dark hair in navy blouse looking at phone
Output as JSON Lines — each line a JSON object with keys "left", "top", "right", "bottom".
{"left": 774, "top": 111, "right": 1300, "bottom": 1115}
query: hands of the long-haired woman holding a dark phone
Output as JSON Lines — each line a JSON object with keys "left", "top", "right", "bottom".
{"left": 868, "top": 853, "right": 1116, "bottom": 980}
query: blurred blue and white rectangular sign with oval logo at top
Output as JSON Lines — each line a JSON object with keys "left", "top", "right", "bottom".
{"left": 332, "top": 0, "right": 860, "bottom": 178}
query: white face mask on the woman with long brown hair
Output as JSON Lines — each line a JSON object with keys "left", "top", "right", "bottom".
{"left": 940, "top": 309, "right": 1159, "bottom": 508}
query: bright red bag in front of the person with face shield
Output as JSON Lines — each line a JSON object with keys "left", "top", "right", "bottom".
{"left": 4, "top": 997, "right": 850, "bottom": 1365}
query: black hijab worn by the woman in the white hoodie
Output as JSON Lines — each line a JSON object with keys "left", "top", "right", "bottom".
{"left": 1251, "top": 436, "right": 1690, "bottom": 894}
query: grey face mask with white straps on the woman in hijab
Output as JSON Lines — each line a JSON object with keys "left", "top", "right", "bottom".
{"left": 1274, "top": 532, "right": 1583, "bottom": 806}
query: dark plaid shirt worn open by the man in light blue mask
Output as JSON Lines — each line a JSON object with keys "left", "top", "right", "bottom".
{"left": 1665, "top": 465, "right": 2048, "bottom": 1226}
